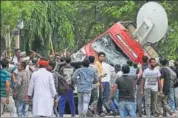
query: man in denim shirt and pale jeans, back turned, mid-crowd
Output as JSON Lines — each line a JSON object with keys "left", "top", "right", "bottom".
{"left": 72, "top": 59, "right": 98, "bottom": 117}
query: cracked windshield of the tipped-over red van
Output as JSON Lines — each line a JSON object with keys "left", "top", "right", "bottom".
{"left": 91, "top": 34, "right": 129, "bottom": 65}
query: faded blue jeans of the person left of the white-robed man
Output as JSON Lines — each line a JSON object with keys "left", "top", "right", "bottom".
{"left": 15, "top": 100, "right": 29, "bottom": 118}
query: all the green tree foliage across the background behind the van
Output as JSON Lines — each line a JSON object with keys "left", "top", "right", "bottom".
{"left": 1, "top": 0, "right": 178, "bottom": 58}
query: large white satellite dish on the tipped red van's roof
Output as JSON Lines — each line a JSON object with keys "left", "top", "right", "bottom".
{"left": 134, "top": 2, "right": 168, "bottom": 44}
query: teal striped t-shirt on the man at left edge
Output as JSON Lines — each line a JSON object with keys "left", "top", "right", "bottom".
{"left": 0, "top": 69, "right": 11, "bottom": 97}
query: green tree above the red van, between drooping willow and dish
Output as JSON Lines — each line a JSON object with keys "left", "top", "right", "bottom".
{"left": 72, "top": 1, "right": 135, "bottom": 49}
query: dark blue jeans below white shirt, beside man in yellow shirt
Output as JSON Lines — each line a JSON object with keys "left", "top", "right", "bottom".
{"left": 102, "top": 82, "right": 116, "bottom": 112}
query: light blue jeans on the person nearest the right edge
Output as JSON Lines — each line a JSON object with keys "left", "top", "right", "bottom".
{"left": 168, "top": 88, "right": 175, "bottom": 112}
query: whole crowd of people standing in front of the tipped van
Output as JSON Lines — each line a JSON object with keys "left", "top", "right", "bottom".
{"left": 0, "top": 49, "right": 178, "bottom": 117}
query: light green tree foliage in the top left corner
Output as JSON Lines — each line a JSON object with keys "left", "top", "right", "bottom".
{"left": 1, "top": 1, "right": 33, "bottom": 34}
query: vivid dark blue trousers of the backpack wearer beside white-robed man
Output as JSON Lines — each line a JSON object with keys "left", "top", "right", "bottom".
{"left": 58, "top": 89, "right": 75, "bottom": 117}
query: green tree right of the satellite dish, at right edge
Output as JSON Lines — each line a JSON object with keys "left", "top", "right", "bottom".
{"left": 158, "top": 1, "right": 178, "bottom": 59}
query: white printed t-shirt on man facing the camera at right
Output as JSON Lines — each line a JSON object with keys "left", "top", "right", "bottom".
{"left": 143, "top": 68, "right": 161, "bottom": 92}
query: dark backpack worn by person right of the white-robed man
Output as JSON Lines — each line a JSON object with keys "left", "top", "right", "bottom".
{"left": 57, "top": 75, "right": 69, "bottom": 95}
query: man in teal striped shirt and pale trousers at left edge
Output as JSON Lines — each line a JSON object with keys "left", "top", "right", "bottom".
{"left": 0, "top": 59, "right": 17, "bottom": 117}
